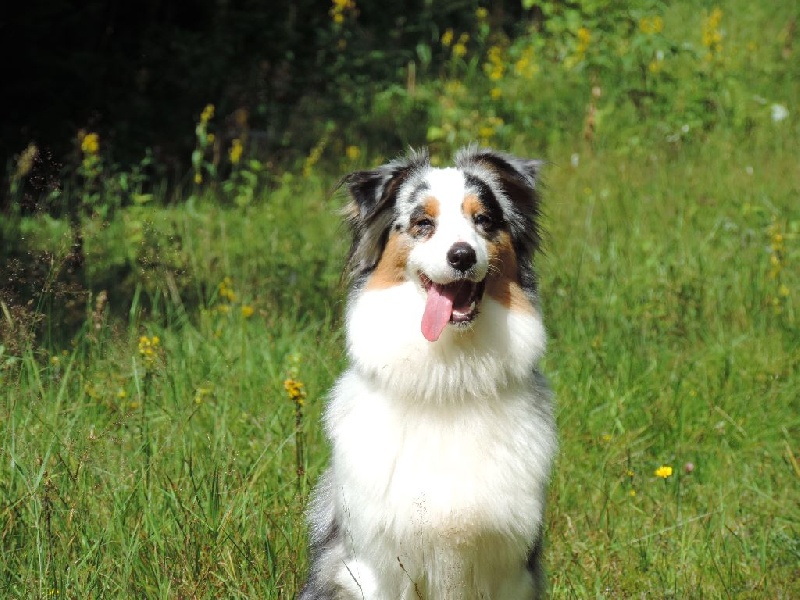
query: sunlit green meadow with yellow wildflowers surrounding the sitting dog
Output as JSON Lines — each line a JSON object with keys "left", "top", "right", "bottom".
{"left": 0, "top": 3, "right": 800, "bottom": 599}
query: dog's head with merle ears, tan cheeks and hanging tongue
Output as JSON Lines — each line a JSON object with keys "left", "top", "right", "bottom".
{"left": 343, "top": 147, "right": 541, "bottom": 342}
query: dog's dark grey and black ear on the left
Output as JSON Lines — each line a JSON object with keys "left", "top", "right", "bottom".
{"left": 339, "top": 150, "right": 430, "bottom": 278}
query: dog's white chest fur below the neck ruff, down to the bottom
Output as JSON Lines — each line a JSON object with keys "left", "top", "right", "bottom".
{"left": 327, "top": 373, "right": 555, "bottom": 598}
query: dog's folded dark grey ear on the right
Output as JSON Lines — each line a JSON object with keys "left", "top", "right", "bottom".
{"left": 455, "top": 146, "right": 544, "bottom": 215}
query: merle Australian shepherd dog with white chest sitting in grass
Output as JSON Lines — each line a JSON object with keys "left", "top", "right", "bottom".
{"left": 299, "top": 146, "right": 557, "bottom": 600}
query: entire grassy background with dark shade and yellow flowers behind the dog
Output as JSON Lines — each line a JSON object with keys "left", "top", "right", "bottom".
{"left": 0, "top": 0, "right": 800, "bottom": 598}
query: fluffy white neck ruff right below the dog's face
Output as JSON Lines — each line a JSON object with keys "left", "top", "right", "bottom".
{"left": 347, "top": 282, "right": 545, "bottom": 404}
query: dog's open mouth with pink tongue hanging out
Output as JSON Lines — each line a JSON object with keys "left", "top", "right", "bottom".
{"left": 419, "top": 273, "right": 486, "bottom": 342}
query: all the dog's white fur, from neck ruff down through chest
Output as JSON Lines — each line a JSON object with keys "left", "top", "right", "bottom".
{"left": 326, "top": 285, "right": 556, "bottom": 600}
